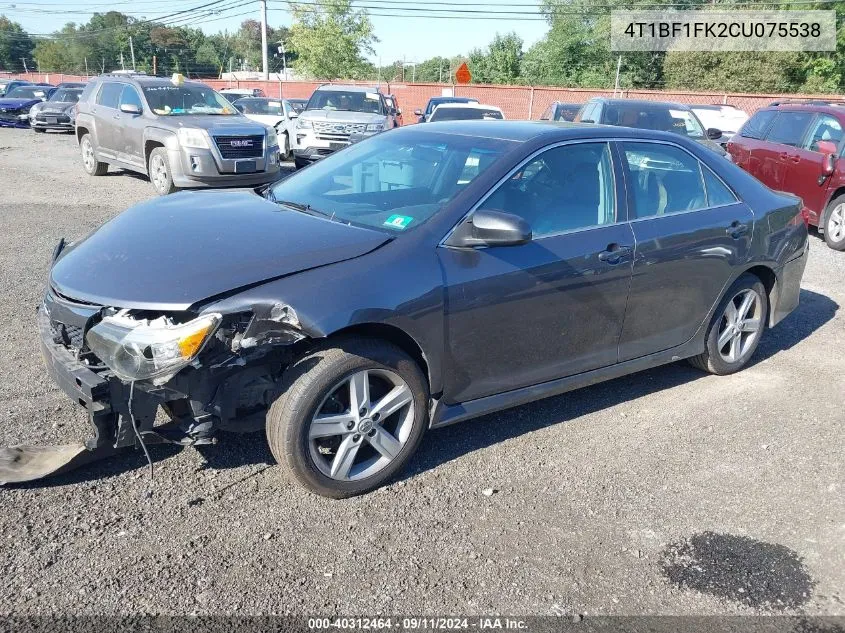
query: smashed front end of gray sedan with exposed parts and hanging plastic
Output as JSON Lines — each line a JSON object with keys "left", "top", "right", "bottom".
{"left": 0, "top": 287, "right": 308, "bottom": 483}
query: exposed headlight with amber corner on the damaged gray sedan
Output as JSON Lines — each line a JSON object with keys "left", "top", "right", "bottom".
{"left": 85, "top": 314, "right": 222, "bottom": 384}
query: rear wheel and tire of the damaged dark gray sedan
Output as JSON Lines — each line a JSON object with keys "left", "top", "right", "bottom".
{"left": 689, "top": 273, "right": 769, "bottom": 376}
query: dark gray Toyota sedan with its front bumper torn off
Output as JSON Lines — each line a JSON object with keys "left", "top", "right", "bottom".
{"left": 18, "top": 121, "right": 808, "bottom": 497}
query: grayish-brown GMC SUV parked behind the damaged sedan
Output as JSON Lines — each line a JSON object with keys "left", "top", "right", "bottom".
{"left": 76, "top": 74, "right": 279, "bottom": 195}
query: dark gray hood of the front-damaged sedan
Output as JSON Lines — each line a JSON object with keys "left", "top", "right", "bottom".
{"left": 50, "top": 191, "right": 390, "bottom": 310}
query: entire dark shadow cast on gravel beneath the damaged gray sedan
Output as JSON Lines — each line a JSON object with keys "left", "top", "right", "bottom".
{"left": 6, "top": 290, "right": 839, "bottom": 488}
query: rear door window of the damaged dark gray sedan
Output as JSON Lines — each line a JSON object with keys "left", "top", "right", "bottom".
{"left": 622, "top": 143, "right": 708, "bottom": 218}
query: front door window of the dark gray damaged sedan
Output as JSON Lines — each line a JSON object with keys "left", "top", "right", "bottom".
{"left": 482, "top": 143, "right": 616, "bottom": 238}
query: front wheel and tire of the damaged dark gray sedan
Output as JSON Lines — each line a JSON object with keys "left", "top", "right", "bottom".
{"left": 267, "top": 338, "right": 429, "bottom": 499}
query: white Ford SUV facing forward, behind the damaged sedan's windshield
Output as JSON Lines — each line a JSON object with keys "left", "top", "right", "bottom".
{"left": 293, "top": 85, "right": 396, "bottom": 169}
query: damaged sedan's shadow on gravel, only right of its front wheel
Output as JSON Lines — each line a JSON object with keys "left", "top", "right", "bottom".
{"left": 400, "top": 289, "right": 839, "bottom": 479}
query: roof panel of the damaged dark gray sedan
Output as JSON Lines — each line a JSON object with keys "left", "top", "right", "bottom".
{"left": 390, "top": 120, "right": 710, "bottom": 143}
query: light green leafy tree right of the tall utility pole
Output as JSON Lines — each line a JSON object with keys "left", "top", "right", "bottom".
{"left": 290, "top": 0, "right": 378, "bottom": 79}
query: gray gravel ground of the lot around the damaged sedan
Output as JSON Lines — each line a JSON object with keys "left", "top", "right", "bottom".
{"left": 0, "top": 130, "right": 845, "bottom": 615}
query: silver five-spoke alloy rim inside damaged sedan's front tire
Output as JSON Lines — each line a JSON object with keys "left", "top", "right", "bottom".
{"left": 308, "top": 369, "right": 414, "bottom": 481}
